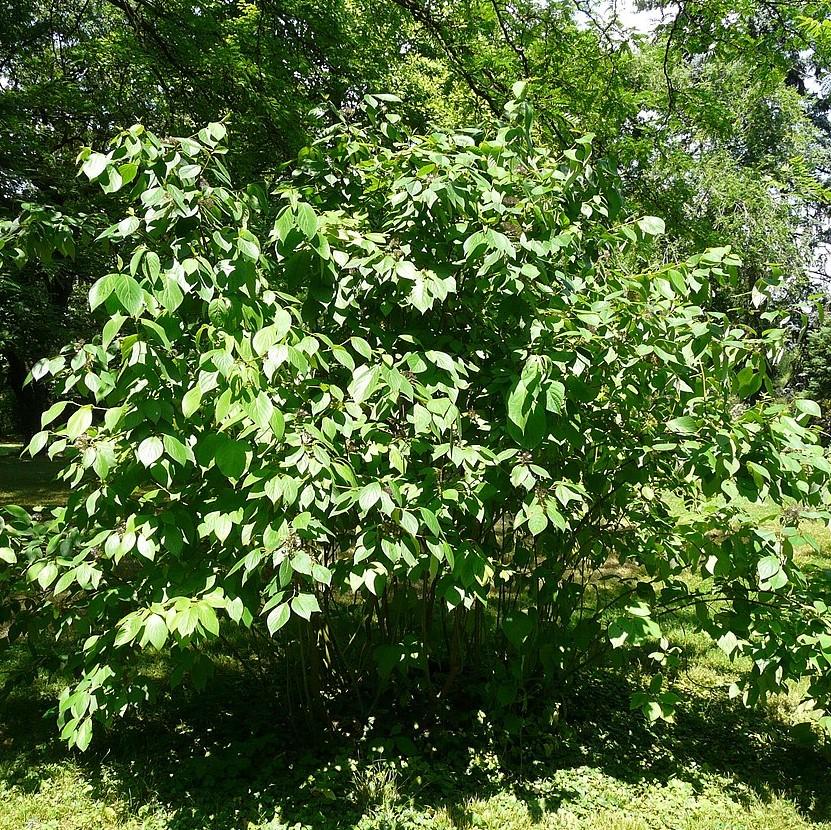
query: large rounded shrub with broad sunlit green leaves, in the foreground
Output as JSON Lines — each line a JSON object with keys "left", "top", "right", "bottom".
{"left": 0, "top": 92, "right": 831, "bottom": 748}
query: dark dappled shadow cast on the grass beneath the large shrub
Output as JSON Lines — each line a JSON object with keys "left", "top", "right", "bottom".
{"left": 0, "top": 660, "right": 831, "bottom": 830}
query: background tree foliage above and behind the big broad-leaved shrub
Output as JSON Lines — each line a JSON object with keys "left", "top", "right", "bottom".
{"left": 0, "top": 0, "right": 831, "bottom": 442}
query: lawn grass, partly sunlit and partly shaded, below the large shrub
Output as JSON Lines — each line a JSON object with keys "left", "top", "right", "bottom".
{"left": 0, "top": 453, "right": 831, "bottom": 830}
